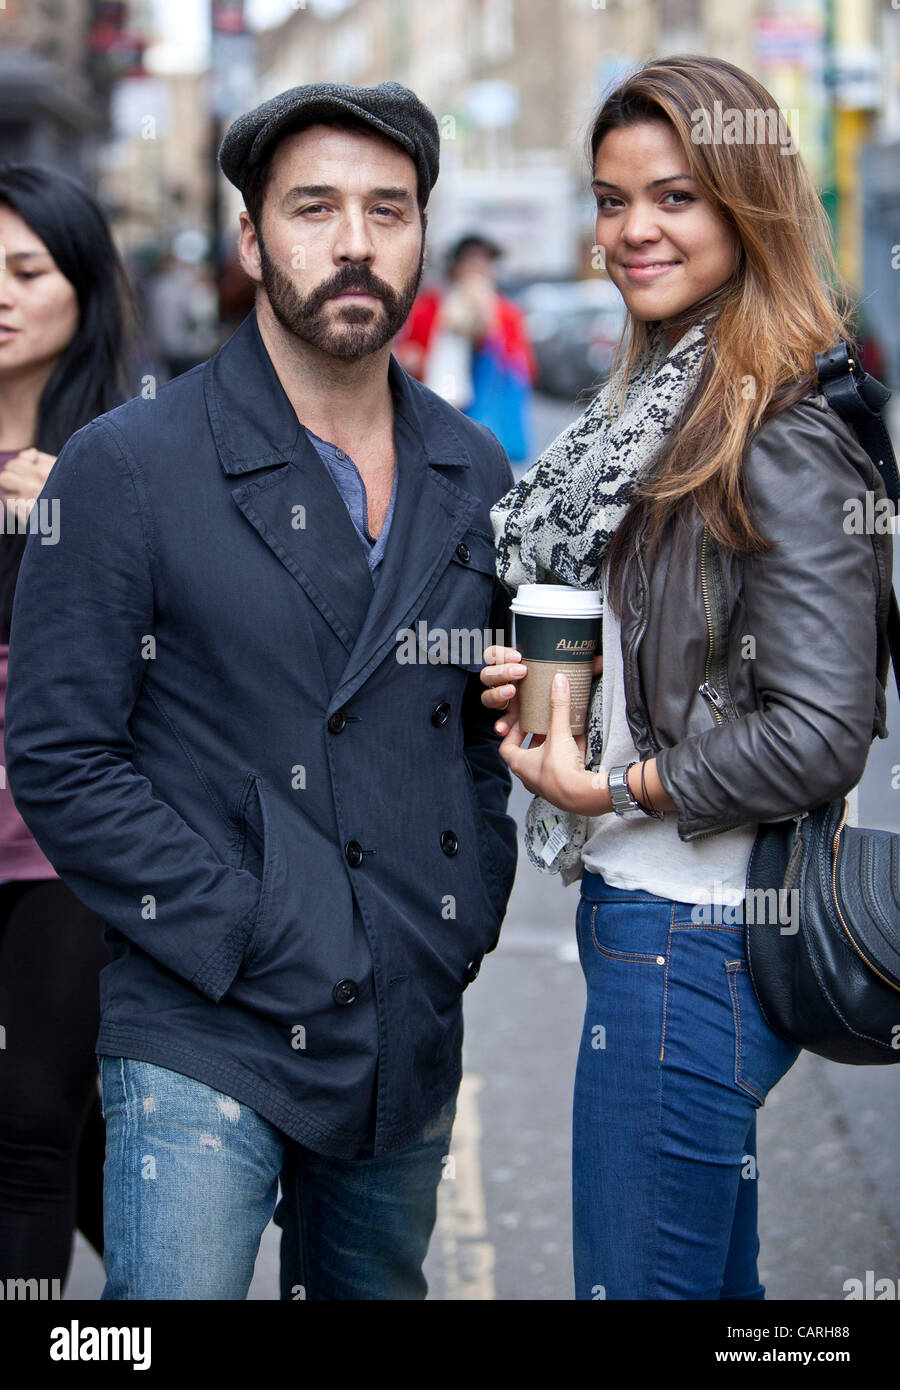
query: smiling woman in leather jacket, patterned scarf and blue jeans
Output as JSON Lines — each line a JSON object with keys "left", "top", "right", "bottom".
{"left": 481, "top": 56, "right": 890, "bottom": 1300}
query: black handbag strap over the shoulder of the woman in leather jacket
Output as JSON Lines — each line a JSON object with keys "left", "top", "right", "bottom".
{"left": 815, "top": 339, "right": 900, "bottom": 695}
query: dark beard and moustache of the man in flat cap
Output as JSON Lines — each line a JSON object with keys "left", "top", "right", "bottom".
{"left": 256, "top": 229, "right": 426, "bottom": 361}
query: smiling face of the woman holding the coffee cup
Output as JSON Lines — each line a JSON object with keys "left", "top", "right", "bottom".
{"left": 591, "top": 121, "right": 740, "bottom": 348}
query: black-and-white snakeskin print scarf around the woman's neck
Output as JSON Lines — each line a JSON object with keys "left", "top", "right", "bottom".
{"left": 491, "top": 310, "right": 716, "bottom": 884}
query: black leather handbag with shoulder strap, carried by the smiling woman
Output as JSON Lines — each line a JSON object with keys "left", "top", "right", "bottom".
{"left": 744, "top": 342, "right": 900, "bottom": 1066}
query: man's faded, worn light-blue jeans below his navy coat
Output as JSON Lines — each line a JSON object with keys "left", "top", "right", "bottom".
{"left": 99, "top": 1056, "right": 455, "bottom": 1300}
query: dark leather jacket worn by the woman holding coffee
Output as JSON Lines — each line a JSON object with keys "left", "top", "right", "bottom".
{"left": 622, "top": 392, "right": 893, "bottom": 840}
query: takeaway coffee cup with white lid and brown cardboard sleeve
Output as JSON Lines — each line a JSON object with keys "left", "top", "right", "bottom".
{"left": 509, "top": 584, "right": 604, "bottom": 734}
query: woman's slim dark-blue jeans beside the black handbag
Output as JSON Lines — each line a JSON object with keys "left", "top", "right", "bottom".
{"left": 573, "top": 873, "right": 800, "bottom": 1300}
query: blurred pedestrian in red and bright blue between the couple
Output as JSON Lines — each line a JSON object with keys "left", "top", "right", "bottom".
{"left": 394, "top": 234, "right": 537, "bottom": 463}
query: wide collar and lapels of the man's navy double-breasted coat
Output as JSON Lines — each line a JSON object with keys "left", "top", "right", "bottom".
{"left": 203, "top": 313, "right": 486, "bottom": 689}
